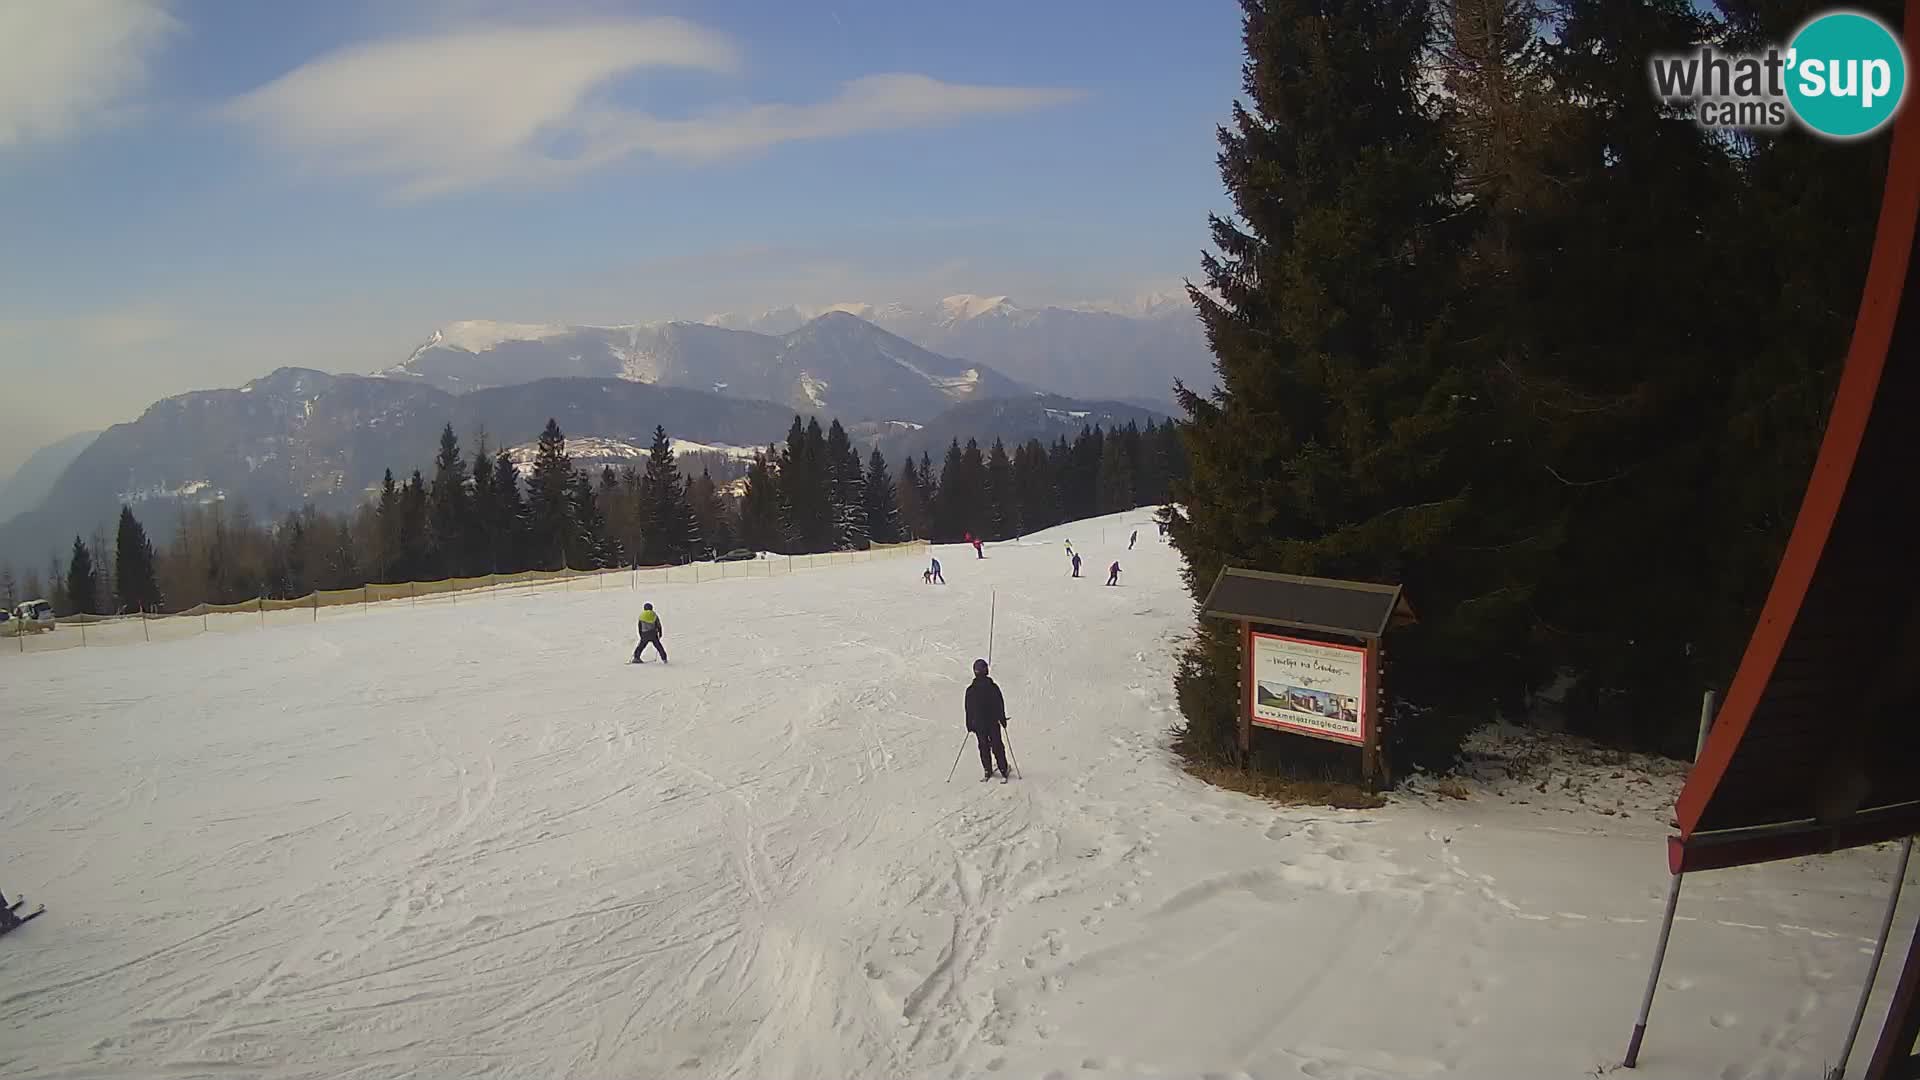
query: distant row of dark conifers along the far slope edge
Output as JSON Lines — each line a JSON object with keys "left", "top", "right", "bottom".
{"left": 11, "top": 417, "right": 1185, "bottom": 615}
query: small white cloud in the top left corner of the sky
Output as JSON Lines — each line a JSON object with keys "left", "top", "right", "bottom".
{"left": 0, "top": 0, "right": 180, "bottom": 148}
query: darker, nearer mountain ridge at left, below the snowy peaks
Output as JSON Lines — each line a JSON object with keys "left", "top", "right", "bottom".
{"left": 0, "top": 367, "right": 793, "bottom": 565}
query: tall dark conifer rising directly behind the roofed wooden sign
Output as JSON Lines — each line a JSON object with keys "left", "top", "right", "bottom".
{"left": 1171, "top": 0, "right": 1497, "bottom": 755}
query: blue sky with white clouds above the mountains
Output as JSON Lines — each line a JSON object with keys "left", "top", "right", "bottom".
{"left": 0, "top": 0, "right": 1240, "bottom": 475}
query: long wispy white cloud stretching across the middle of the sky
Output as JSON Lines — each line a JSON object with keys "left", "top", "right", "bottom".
{"left": 225, "top": 17, "right": 1077, "bottom": 198}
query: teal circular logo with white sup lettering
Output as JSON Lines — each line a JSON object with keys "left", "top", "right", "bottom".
{"left": 1788, "top": 12, "right": 1907, "bottom": 138}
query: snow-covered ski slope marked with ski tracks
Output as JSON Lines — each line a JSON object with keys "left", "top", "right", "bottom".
{"left": 0, "top": 511, "right": 1912, "bottom": 1080}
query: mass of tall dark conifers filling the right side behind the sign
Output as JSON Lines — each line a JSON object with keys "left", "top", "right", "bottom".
{"left": 1169, "top": 0, "right": 1901, "bottom": 765}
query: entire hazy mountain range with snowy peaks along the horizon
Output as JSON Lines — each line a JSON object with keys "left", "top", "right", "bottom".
{"left": 0, "top": 296, "right": 1212, "bottom": 561}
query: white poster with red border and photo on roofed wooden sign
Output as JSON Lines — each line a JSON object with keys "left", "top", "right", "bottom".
{"left": 1250, "top": 632, "right": 1367, "bottom": 746}
